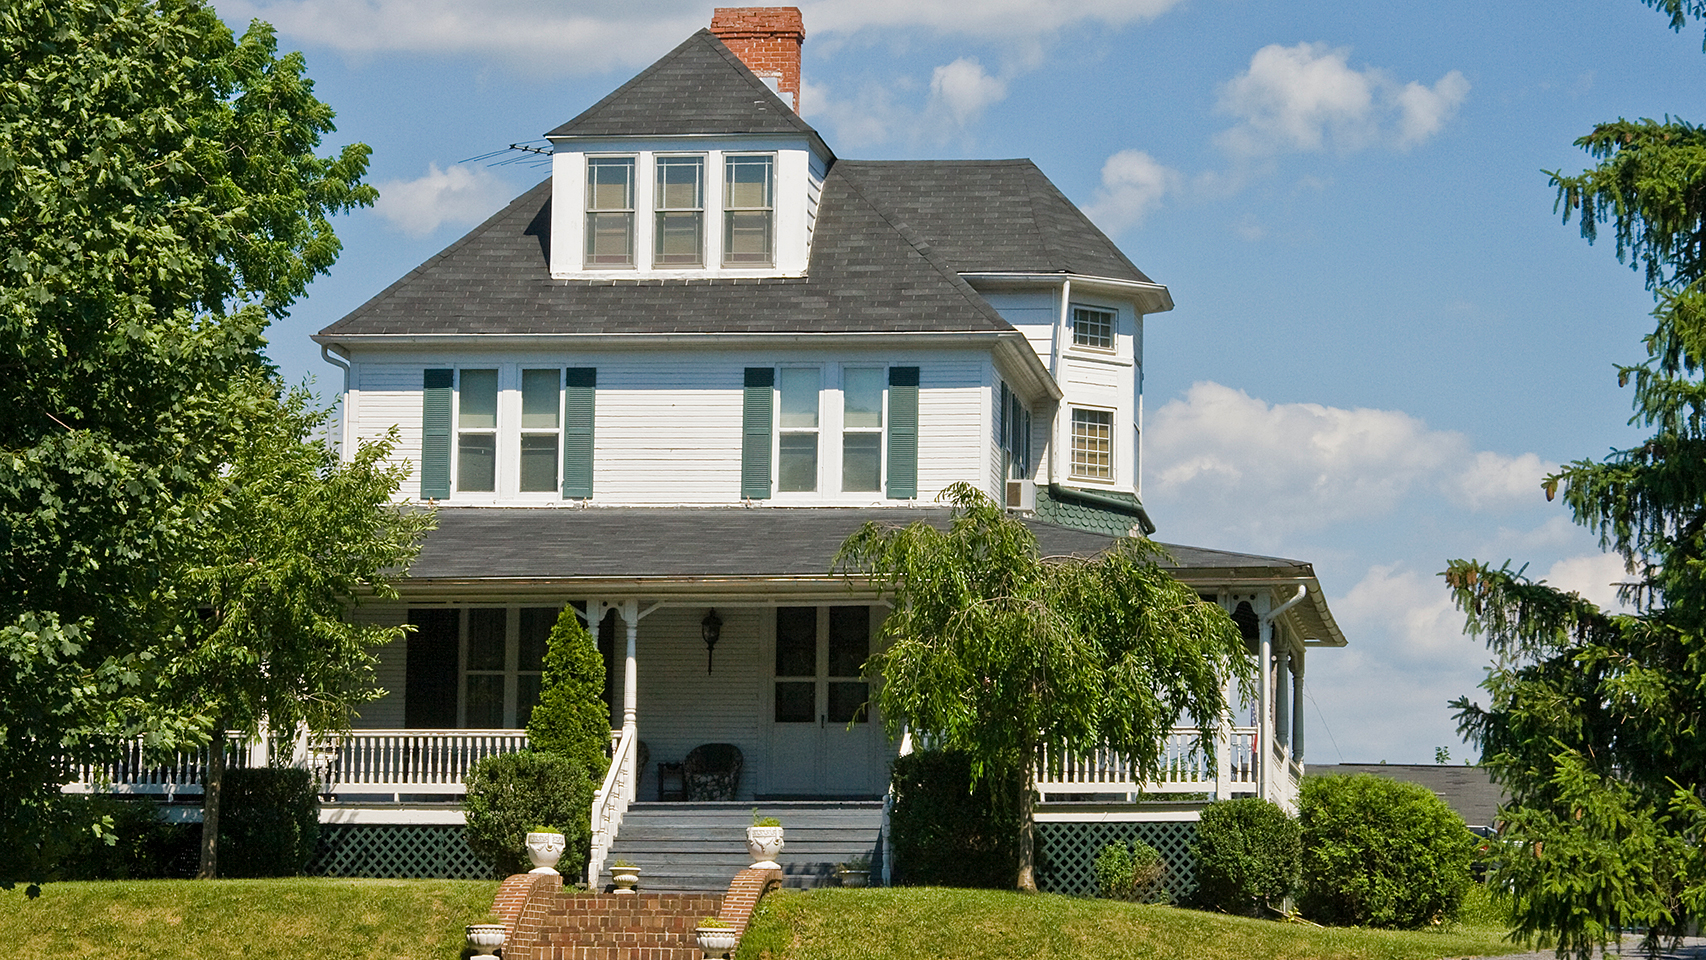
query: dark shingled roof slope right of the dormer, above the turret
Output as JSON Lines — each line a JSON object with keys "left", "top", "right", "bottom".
{"left": 836, "top": 160, "right": 1152, "bottom": 283}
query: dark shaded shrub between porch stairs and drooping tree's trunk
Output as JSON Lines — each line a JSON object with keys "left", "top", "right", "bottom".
{"left": 889, "top": 750, "right": 1016, "bottom": 890}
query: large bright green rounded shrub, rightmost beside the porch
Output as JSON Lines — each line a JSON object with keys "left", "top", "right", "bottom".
{"left": 1300, "top": 774, "right": 1476, "bottom": 928}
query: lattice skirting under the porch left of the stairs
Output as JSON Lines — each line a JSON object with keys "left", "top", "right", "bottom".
{"left": 309, "top": 824, "right": 493, "bottom": 880}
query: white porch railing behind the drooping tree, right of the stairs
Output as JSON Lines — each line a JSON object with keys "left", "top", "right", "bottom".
{"left": 1037, "top": 726, "right": 1269, "bottom": 801}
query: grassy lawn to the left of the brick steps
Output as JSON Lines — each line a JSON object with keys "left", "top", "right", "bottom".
{"left": 0, "top": 878, "right": 498, "bottom": 960}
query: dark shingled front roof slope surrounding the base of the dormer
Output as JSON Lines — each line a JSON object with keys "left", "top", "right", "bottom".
{"left": 317, "top": 164, "right": 1013, "bottom": 341}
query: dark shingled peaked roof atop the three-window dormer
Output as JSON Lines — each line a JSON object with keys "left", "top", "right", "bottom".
{"left": 546, "top": 29, "right": 822, "bottom": 143}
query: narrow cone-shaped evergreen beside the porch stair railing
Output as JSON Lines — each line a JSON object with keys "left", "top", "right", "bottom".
{"left": 527, "top": 607, "right": 611, "bottom": 784}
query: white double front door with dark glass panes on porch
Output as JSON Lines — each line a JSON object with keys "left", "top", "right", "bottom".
{"left": 769, "top": 607, "right": 885, "bottom": 796}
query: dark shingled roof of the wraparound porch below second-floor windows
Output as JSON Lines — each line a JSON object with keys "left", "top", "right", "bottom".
{"left": 409, "top": 506, "right": 1307, "bottom": 580}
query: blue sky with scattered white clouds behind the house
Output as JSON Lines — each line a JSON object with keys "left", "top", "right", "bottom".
{"left": 215, "top": 0, "right": 1706, "bottom": 762}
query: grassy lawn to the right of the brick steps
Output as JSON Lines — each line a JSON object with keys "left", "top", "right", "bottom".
{"left": 737, "top": 887, "right": 1522, "bottom": 960}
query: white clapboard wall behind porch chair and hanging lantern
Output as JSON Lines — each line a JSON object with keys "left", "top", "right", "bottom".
{"left": 634, "top": 607, "right": 769, "bottom": 800}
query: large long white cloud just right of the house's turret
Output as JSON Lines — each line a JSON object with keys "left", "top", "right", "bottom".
{"left": 1145, "top": 382, "right": 1551, "bottom": 544}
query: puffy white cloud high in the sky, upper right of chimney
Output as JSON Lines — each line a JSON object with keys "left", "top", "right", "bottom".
{"left": 1218, "top": 43, "right": 1469, "bottom": 157}
